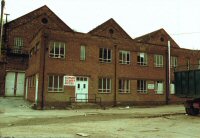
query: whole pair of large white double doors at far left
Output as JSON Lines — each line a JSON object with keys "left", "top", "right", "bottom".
{"left": 5, "top": 72, "right": 25, "bottom": 96}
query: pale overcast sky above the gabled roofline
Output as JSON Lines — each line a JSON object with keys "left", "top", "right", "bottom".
{"left": 5, "top": 0, "right": 200, "bottom": 49}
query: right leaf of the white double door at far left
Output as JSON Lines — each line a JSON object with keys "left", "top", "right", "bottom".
{"left": 16, "top": 72, "right": 25, "bottom": 96}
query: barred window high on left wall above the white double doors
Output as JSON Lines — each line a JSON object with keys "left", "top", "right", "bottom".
{"left": 13, "top": 37, "right": 24, "bottom": 53}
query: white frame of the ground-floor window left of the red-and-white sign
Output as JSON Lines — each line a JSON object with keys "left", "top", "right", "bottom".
{"left": 48, "top": 75, "right": 63, "bottom": 92}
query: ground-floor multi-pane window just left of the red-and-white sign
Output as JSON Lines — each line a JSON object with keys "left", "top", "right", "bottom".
{"left": 48, "top": 75, "right": 63, "bottom": 92}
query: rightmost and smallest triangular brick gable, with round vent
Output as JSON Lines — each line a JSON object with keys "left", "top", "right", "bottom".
{"left": 134, "top": 28, "right": 179, "bottom": 48}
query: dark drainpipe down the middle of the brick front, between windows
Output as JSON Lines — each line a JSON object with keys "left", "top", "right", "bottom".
{"left": 113, "top": 45, "right": 117, "bottom": 106}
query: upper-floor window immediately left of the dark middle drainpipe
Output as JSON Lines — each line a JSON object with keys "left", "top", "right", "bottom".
{"left": 99, "top": 48, "right": 112, "bottom": 63}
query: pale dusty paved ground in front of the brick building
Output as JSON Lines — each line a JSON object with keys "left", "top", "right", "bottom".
{"left": 0, "top": 98, "right": 200, "bottom": 138}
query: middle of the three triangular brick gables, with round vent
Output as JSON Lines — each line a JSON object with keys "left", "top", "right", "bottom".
{"left": 88, "top": 18, "right": 132, "bottom": 39}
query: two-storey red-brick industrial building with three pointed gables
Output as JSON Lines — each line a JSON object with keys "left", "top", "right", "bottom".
{"left": 1, "top": 6, "right": 200, "bottom": 107}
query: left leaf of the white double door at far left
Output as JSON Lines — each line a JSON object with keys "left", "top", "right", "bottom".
{"left": 5, "top": 72, "right": 15, "bottom": 96}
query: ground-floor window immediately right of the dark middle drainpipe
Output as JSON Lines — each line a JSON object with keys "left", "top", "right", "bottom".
{"left": 119, "top": 80, "right": 130, "bottom": 93}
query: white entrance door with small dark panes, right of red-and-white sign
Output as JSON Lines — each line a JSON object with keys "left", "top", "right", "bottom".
{"left": 76, "top": 77, "right": 88, "bottom": 102}
